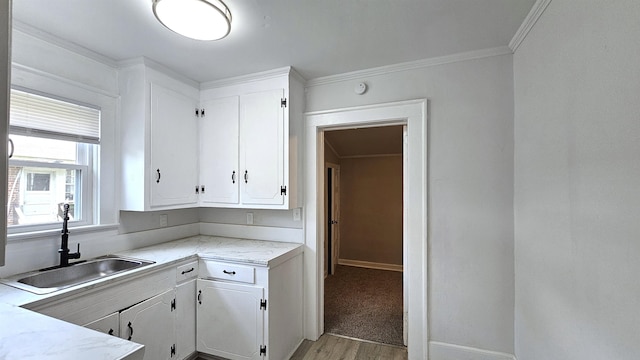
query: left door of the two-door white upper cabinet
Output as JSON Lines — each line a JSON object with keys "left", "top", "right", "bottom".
{"left": 200, "top": 96, "right": 241, "bottom": 205}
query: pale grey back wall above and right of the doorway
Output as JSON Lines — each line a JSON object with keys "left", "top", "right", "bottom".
{"left": 307, "top": 54, "right": 514, "bottom": 359}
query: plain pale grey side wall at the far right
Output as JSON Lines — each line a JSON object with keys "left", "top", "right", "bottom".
{"left": 514, "top": 0, "right": 640, "bottom": 360}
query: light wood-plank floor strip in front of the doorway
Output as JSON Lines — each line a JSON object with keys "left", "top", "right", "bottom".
{"left": 291, "top": 334, "right": 407, "bottom": 360}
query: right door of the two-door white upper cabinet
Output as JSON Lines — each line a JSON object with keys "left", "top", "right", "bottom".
{"left": 240, "top": 89, "right": 285, "bottom": 205}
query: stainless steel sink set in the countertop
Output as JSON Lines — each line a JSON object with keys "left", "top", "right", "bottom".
{"left": 3, "top": 255, "right": 154, "bottom": 294}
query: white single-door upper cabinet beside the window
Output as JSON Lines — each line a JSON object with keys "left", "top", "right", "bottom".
{"left": 120, "top": 63, "right": 199, "bottom": 211}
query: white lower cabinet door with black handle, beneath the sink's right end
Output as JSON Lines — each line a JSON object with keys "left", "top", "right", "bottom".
{"left": 120, "top": 290, "right": 176, "bottom": 360}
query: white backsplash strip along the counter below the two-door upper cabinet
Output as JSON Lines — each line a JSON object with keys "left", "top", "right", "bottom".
{"left": 200, "top": 223, "right": 304, "bottom": 244}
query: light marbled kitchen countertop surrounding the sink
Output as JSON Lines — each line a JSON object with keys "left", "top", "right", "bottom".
{"left": 0, "top": 235, "right": 302, "bottom": 360}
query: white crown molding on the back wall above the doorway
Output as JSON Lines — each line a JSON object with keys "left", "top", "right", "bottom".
{"left": 306, "top": 46, "right": 512, "bottom": 88}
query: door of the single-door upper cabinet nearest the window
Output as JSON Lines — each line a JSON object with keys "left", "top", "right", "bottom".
{"left": 149, "top": 83, "right": 198, "bottom": 206}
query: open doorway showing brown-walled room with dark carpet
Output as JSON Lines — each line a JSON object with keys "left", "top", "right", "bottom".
{"left": 324, "top": 125, "right": 406, "bottom": 346}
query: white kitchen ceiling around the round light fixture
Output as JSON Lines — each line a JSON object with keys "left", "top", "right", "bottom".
{"left": 13, "top": 0, "right": 535, "bottom": 82}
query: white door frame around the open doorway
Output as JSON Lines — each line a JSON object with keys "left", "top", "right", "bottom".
{"left": 304, "top": 99, "right": 428, "bottom": 359}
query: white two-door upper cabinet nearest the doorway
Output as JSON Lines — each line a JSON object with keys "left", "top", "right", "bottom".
{"left": 200, "top": 67, "right": 304, "bottom": 209}
